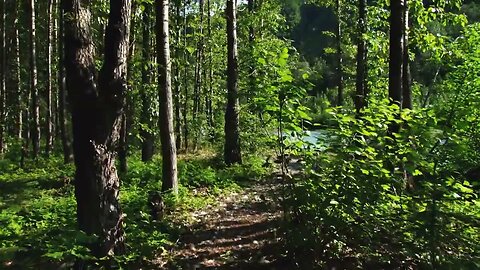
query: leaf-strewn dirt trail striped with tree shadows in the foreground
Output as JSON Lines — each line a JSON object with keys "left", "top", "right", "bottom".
{"left": 155, "top": 177, "right": 290, "bottom": 269}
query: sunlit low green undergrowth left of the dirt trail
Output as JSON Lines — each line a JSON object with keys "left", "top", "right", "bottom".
{"left": 0, "top": 152, "right": 267, "bottom": 269}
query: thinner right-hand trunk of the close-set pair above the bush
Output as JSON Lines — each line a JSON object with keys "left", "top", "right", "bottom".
{"left": 402, "top": 0, "right": 413, "bottom": 109}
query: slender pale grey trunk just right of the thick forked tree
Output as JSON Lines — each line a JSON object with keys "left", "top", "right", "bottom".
{"left": 155, "top": 0, "right": 178, "bottom": 194}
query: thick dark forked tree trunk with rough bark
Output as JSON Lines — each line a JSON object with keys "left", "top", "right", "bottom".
{"left": 65, "top": 0, "right": 131, "bottom": 256}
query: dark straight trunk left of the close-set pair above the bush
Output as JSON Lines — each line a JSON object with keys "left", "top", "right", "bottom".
{"left": 355, "top": 0, "right": 367, "bottom": 114}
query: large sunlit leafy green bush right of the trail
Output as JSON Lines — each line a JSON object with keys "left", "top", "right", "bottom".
{"left": 290, "top": 101, "right": 480, "bottom": 269}
